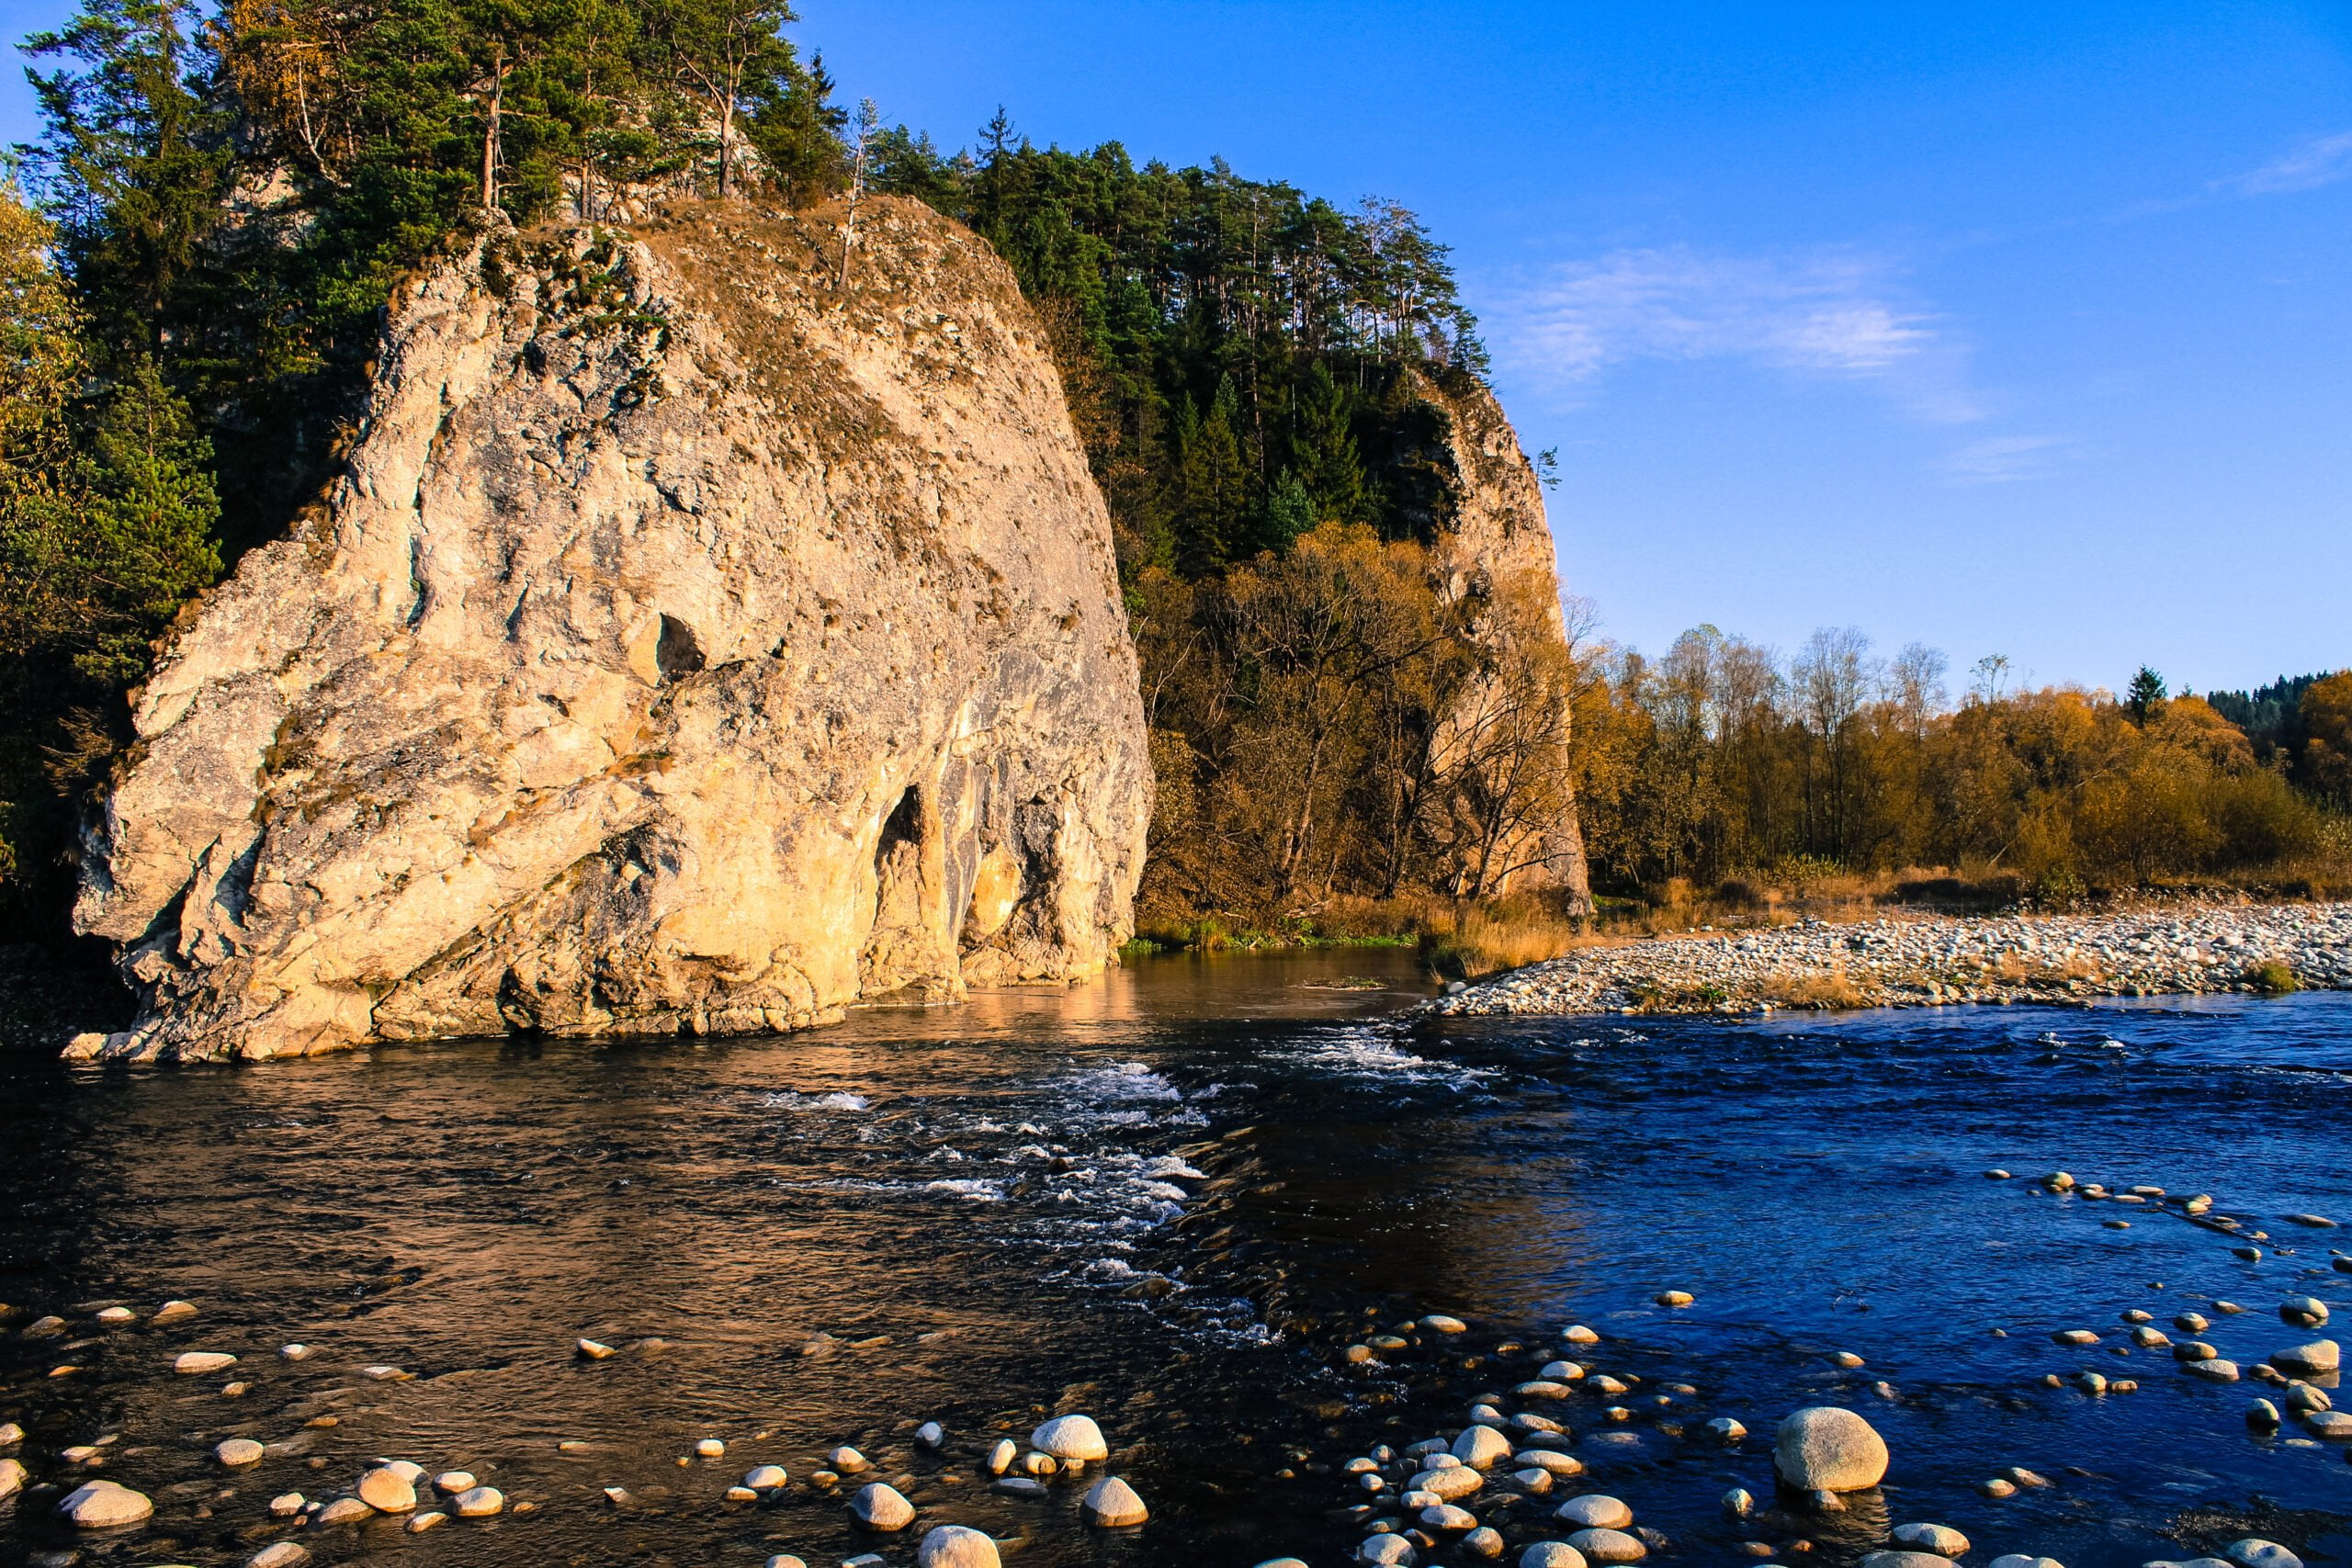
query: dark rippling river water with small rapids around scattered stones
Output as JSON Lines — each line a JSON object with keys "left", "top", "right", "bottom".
{"left": 0, "top": 952, "right": 2352, "bottom": 1568}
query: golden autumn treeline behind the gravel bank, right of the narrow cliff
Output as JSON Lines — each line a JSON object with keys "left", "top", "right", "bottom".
{"left": 1576, "top": 627, "right": 2352, "bottom": 898}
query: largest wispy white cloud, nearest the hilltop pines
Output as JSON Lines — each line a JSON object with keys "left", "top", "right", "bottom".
{"left": 1488, "top": 247, "right": 1983, "bottom": 423}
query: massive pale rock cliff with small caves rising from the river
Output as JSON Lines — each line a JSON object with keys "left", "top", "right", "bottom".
{"left": 73, "top": 190, "right": 1150, "bottom": 1058}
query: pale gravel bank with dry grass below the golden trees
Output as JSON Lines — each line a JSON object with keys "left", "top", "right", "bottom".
{"left": 1430, "top": 903, "right": 2352, "bottom": 1013}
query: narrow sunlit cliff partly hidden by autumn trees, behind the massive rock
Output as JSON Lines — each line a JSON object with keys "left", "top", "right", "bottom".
{"left": 1419, "top": 371, "right": 1592, "bottom": 915}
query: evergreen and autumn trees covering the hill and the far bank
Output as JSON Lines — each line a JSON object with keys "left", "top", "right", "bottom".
{"left": 0, "top": 0, "right": 2352, "bottom": 968}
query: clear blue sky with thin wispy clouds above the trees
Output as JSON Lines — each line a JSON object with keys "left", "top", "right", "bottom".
{"left": 0, "top": 0, "right": 2352, "bottom": 689}
